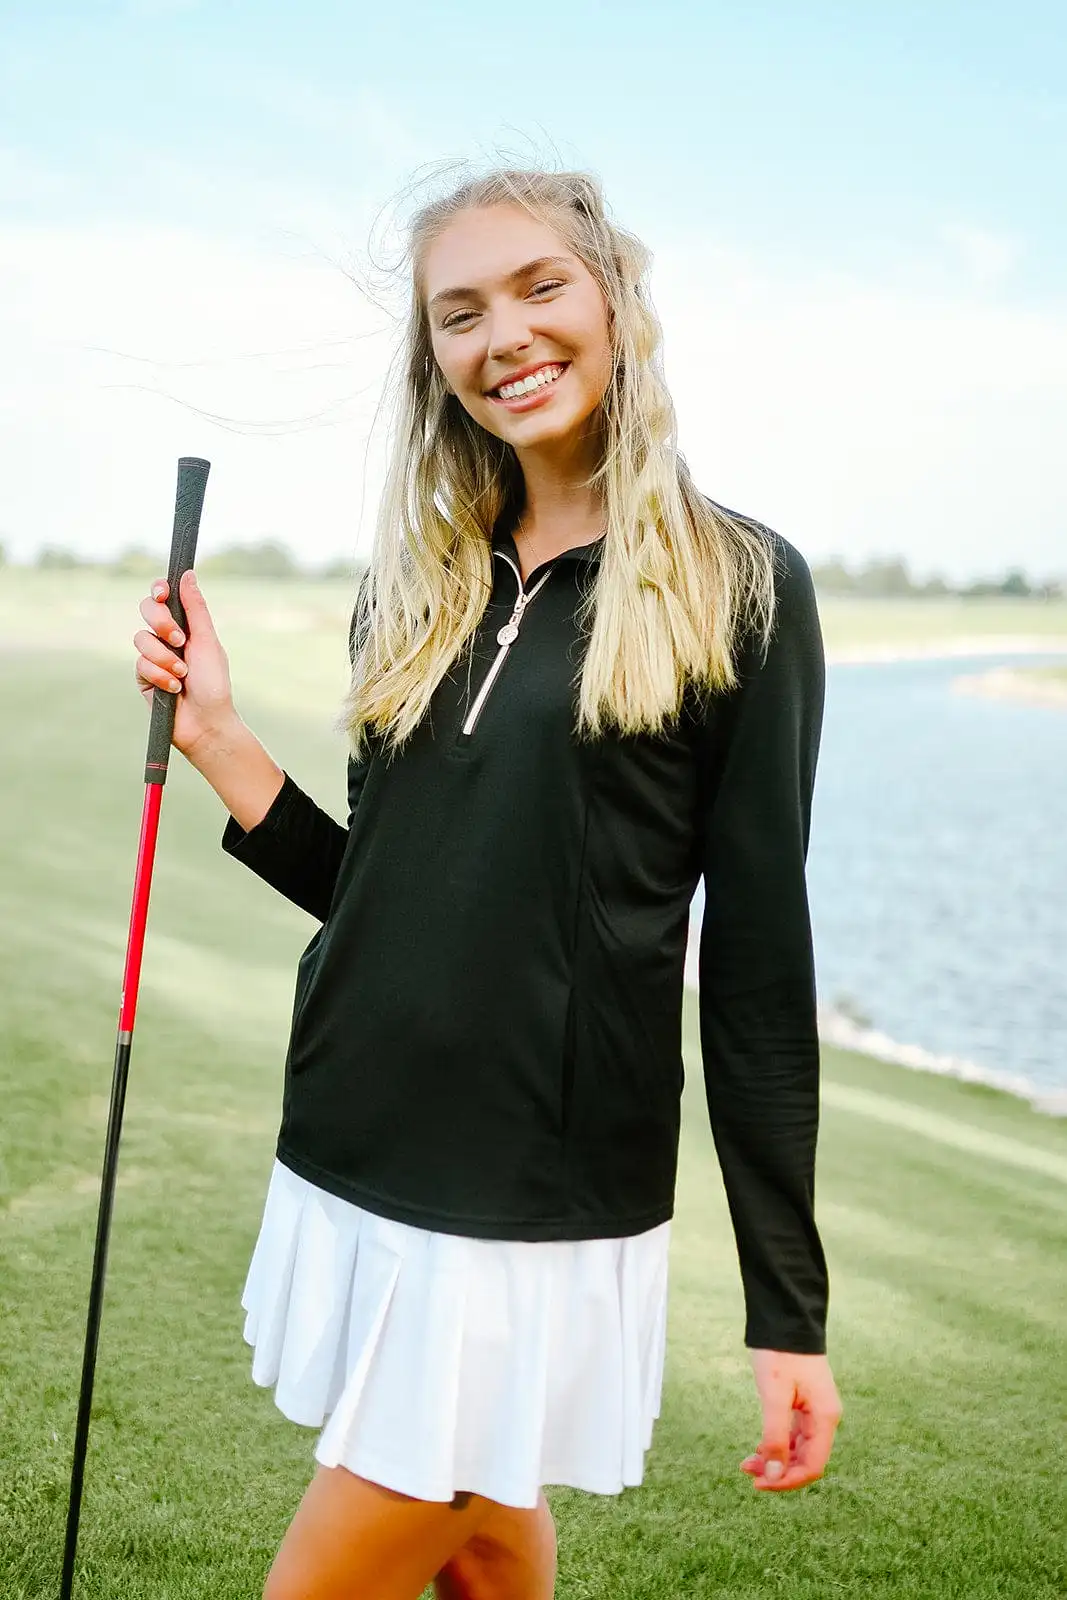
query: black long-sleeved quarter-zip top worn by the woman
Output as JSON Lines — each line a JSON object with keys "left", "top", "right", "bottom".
{"left": 222, "top": 508, "right": 829, "bottom": 1354}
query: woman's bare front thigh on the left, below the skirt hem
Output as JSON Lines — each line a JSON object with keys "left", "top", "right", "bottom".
{"left": 262, "top": 1467, "right": 502, "bottom": 1600}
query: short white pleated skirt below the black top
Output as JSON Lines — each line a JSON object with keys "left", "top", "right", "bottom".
{"left": 242, "top": 1162, "right": 670, "bottom": 1507}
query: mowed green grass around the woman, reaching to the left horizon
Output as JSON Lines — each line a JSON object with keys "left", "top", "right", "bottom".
{"left": 0, "top": 573, "right": 1067, "bottom": 1600}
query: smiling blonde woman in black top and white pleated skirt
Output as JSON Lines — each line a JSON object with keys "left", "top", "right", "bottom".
{"left": 134, "top": 171, "right": 840, "bottom": 1600}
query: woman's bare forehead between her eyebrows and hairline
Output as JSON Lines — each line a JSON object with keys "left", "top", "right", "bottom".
{"left": 422, "top": 205, "right": 579, "bottom": 302}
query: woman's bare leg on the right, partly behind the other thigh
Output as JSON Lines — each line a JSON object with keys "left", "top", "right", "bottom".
{"left": 434, "top": 1491, "right": 557, "bottom": 1600}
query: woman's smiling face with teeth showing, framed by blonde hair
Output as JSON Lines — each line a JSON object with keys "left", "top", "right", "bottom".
{"left": 422, "top": 205, "right": 611, "bottom": 461}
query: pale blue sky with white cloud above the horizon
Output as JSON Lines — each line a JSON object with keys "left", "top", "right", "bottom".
{"left": 0, "top": 0, "right": 1067, "bottom": 576}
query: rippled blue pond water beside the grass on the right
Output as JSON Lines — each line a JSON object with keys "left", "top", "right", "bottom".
{"left": 689, "top": 654, "right": 1067, "bottom": 1093}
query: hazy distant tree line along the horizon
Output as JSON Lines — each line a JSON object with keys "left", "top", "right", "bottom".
{"left": 0, "top": 539, "right": 1067, "bottom": 600}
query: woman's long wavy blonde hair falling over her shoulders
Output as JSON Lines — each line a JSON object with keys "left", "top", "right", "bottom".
{"left": 336, "top": 168, "right": 774, "bottom": 757}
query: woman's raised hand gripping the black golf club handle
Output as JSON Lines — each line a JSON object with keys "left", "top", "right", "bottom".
{"left": 133, "top": 568, "right": 237, "bottom": 755}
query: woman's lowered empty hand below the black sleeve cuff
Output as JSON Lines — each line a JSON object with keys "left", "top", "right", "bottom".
{"left": 741, "top": 1350, "right": 841, "bottom": 1490}
